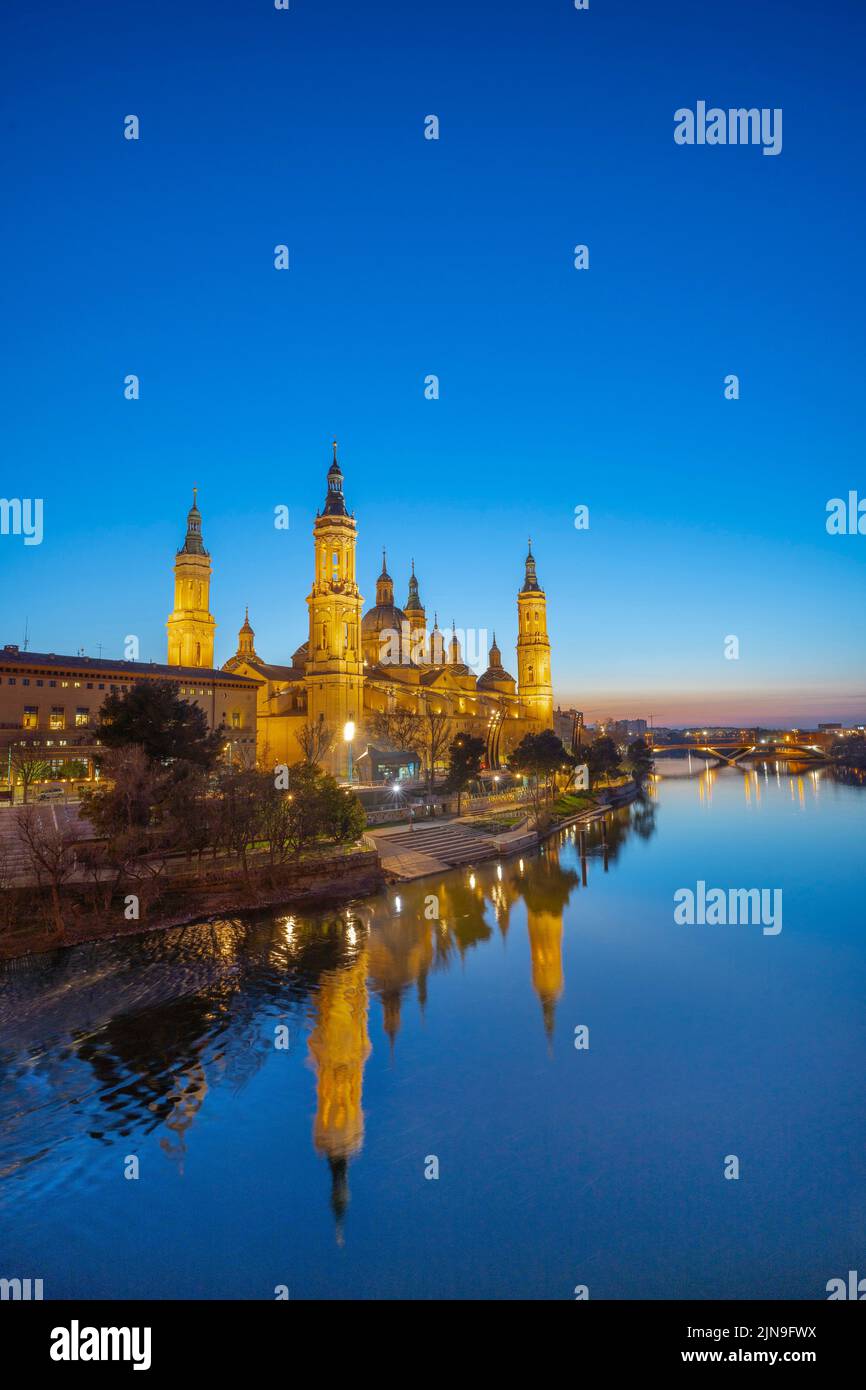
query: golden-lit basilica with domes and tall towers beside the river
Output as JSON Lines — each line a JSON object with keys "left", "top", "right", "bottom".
{"left": 167, "top": 442, "right": 553, "bottom": 777}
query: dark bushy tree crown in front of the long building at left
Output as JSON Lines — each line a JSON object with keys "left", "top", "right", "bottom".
{"left": 96, "top": 681, "right": 225, "bottom": 769}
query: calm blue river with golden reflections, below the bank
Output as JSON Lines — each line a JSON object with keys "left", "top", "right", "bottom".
{"left": 0, "top": 769, "right": 866, "bottom": 1298}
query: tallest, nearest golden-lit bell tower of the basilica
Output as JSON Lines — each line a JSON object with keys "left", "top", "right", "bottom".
{"left": 306, "top": 439, "right": 364, "bottom": 777}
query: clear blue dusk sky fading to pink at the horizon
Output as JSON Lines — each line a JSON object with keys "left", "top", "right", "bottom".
{"left": 0, "top": 0, "right": 866, "bottom": 724}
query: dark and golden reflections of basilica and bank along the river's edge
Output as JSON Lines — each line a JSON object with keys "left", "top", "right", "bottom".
{"left": 0, "top": 798, "right": 656, "bottom": 1241}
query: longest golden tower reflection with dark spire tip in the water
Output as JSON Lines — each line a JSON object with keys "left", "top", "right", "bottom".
{"left": 307, "top": 949, "right": 371, "bottom": 1244}
